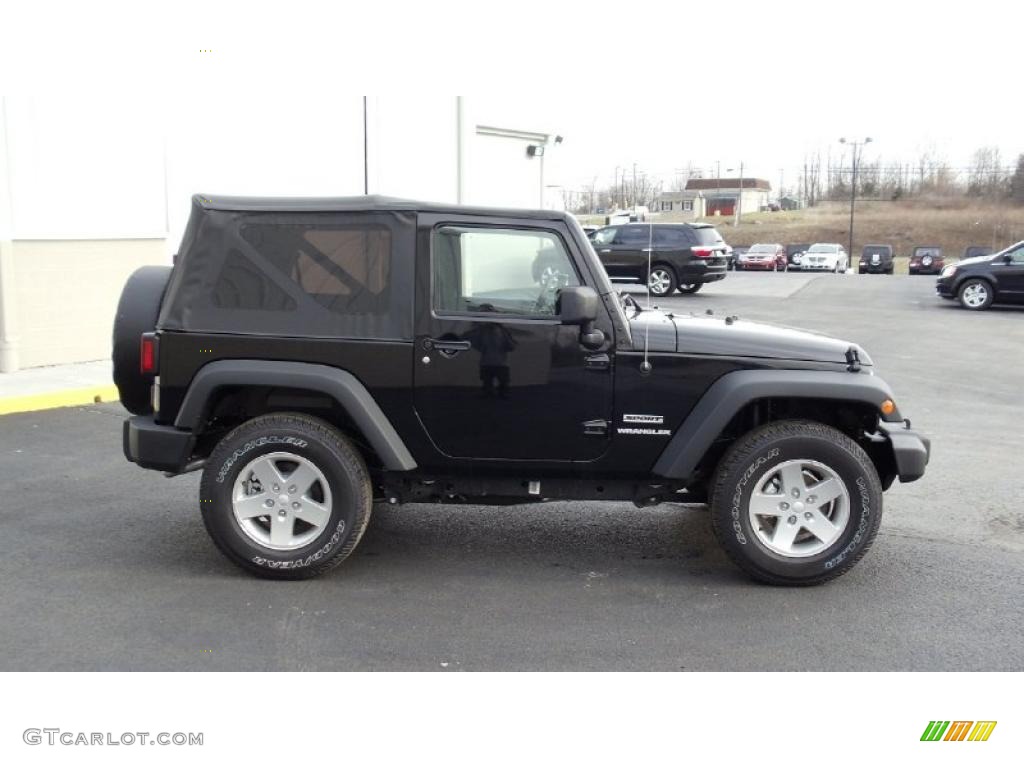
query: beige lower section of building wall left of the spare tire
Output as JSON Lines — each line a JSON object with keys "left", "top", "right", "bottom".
{"left": 12, "top": 239, "right": 170, "bottom": 368}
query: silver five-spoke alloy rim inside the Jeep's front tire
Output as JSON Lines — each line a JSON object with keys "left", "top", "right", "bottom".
{"left": 748, "top": 459, "right": 850, "bottom": 557}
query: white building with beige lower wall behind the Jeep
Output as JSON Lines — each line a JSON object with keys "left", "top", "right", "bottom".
{"left": 0, "top": 96, "right": 558, "bottom": 372}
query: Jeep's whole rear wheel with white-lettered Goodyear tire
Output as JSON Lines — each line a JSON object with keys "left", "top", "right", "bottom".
{"left": 200, "top": 414, "right": 373, "bottom": 580}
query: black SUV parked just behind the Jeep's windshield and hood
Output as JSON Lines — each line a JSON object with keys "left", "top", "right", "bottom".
{"left": 591, "top": 224, "right": 729, "bottom": 296}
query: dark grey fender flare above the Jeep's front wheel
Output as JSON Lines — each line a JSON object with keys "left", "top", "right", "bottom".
{"left": 652, "top": 369, "right": 903, "bottom": 481}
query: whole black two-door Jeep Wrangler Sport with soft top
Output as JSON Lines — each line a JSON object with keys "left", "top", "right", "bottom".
{"left": 114, "top": 196, "right": 929, "bottom": 585}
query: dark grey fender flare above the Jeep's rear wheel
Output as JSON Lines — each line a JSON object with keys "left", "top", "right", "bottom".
{"left": 174, "top": 359, "right": 417, "bottom": 472}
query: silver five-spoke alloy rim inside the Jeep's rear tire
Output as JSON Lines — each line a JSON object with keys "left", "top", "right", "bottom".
{"left": 231, "top": 452, "right": 331, "bottom": 550}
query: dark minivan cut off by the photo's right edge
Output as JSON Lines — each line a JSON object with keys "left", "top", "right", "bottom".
{"left": 935, "top": 241, "right": 1024, "bottom": 309}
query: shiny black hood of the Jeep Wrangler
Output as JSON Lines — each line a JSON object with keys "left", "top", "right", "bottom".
{"left": 630, "top": 310, "right": 871, "bottom": 366}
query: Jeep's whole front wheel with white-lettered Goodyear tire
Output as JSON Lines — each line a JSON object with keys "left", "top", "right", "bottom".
{"left": 711, "top": 420, "right": 882, "bottom": 586}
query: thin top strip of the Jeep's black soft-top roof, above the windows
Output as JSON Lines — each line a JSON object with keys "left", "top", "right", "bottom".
{"left": 193, "top": 195, "right": 571, "bottom": 221}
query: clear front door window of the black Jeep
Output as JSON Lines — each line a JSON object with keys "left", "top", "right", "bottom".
{"left": 431, "top": 226, "right": 580, "bottom": 317}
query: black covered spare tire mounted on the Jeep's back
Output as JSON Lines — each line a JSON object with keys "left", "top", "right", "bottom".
{"left": 112, "top": 266, "right": 171, "bottom": 415}
